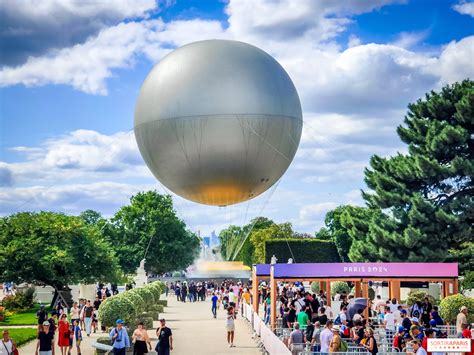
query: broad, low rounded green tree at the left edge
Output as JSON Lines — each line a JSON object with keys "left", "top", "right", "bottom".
{"left": 0, "top": 212, "right": 121, "bottom": 300}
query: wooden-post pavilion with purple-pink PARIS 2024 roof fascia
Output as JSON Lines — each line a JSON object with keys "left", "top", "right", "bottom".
{"left": 252, "top": 262, "right": 458, "bottom": 328}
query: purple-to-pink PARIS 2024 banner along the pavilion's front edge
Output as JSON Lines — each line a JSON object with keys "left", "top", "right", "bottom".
{"left": 273, "top": 263, "right": 458, "bottom": 278}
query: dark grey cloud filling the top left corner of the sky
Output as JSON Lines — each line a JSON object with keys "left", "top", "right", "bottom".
{"left": 0, "top": 0, "right": 157, "bottom": 66}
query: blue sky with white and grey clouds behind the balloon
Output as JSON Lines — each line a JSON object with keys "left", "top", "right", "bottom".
{"left": 0, "top": 0, "right": 474, "bottom": 235}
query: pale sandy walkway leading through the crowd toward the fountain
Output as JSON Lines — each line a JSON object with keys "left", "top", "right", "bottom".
{"left": 20, "top": 296, "right": 261, "bottom": 355}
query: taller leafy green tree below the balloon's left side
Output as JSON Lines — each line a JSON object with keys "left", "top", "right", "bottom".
{"left": 109, "top": 191, "right": 200, "bottom": 274}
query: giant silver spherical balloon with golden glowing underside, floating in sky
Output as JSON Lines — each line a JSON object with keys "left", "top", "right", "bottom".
{"left": 135, "top": 40, "right": 302, "bottom": 206}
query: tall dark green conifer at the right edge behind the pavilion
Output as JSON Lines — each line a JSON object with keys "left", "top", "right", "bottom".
{"left": 348, "top": 80, "right": 474, "bottom": 271}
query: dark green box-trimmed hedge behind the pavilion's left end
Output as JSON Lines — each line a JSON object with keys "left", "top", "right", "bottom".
{"left": 265, "top": 238, "right": 341, "bottom": 264}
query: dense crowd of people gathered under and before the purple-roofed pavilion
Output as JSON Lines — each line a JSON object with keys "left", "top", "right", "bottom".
{"left": 259, "top": 283, "right": 472, "bottom": 355}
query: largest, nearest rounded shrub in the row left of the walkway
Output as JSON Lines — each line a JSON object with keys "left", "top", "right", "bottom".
{"left": 99, "top": 293, "right": 137, "bottom": 327}
